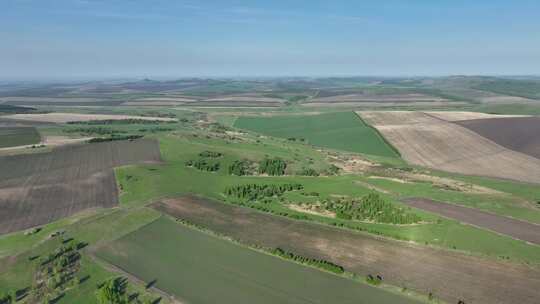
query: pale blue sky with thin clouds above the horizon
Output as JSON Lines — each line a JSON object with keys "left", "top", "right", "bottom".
{"left": 0, "top": 0, "right": 540, "bottom": 80}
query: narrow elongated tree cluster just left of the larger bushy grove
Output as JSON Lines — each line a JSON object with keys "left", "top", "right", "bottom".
{"left": 225, "top": 183, "right": 304, "bottom": 201}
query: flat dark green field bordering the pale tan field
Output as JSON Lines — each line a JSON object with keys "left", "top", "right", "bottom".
{"left": 234, "top": 112, "right": 399, "bottom": 158}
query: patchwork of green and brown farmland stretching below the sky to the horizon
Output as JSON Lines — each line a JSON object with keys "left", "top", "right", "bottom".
{"left": 0, "top": 77, "right": 540, "bottom": 304}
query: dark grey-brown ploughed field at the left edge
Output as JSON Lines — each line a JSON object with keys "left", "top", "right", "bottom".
{"left": 0, "top": 139, "right": 160, "bottom": 234}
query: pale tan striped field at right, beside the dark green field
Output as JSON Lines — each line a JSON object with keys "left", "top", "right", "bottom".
{"left": 358, "top": 111, "right": 540, "bottom": 183}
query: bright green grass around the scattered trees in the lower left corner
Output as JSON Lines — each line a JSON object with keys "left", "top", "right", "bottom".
{"left": 0, "top": 208, "right": 166, "bottom": 304}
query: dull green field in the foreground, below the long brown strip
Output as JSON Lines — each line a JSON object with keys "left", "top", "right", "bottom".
{"left": 98, "top": 217, "right": 417, "bottom": 304}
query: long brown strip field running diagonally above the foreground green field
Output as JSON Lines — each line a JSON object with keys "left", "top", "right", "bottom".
{"left": 153, "top": 197, "right": 540, "bottom": 304}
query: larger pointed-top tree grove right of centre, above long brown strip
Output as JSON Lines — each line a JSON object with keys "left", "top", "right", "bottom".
{"left": 323, "top": 193, "right": 421, "bottom": 224}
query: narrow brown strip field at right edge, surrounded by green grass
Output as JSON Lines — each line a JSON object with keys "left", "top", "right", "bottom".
{"left": 403, "top": 198, "right": 540, "bottom": 245}
